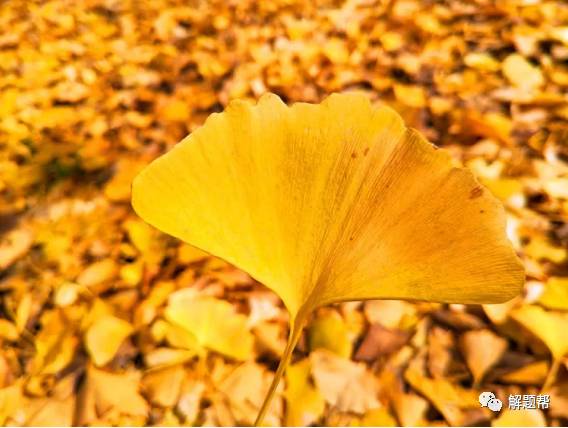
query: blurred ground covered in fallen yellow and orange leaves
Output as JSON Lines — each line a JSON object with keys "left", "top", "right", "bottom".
{"left": 0, "top": 0, "right": 568, "bottom": 426}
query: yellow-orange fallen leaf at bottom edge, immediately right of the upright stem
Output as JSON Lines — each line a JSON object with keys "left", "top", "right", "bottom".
{"left": 285, "top": 358, "right": 325, "bottom": 426}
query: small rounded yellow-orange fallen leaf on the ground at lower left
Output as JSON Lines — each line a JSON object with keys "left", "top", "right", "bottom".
{"left": 85, "top": 315, "right": 133, "bottom": 366}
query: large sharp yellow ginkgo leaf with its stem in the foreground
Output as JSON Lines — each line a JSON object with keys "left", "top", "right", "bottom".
{"left": 132, "top": 94, "right": 524, "bottom": 423}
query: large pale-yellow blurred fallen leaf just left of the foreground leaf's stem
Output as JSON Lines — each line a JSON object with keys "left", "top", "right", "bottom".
{"left": 165, "top": 294, "right": 254, "bottom": 360}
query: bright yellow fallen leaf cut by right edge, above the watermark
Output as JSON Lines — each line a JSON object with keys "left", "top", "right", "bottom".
{"left": 511, "top": 305, "right": 568, "bottom": 360}
